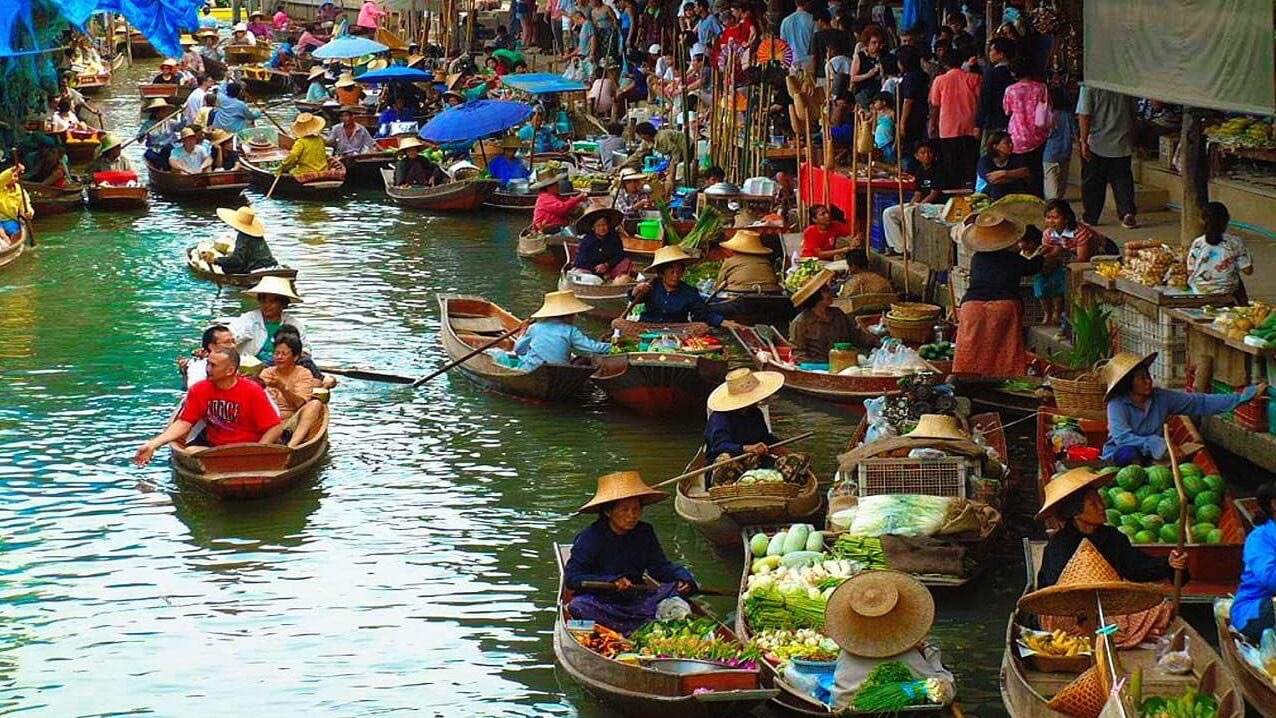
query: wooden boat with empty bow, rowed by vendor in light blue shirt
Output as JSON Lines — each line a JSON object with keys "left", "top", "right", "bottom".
{"left": 439, "top": 295, "right": 593, "bottom": 402}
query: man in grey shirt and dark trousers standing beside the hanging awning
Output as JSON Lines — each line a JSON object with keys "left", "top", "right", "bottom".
{"left": 1077, "top": 84, "right": 1138, "bottom": 230}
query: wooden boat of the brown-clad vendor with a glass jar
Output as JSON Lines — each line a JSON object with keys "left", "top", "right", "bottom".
{"left": 731, "top": 325, "right": 934, "bottom": 406}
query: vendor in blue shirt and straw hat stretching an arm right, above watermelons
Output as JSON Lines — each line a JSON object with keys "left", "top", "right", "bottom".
{"left": 1097, "top": 344, "right": 1267, "bottom": 467}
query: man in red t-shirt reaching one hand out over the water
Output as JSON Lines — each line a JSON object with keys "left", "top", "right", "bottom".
{"left": 133, "top": 347, "right": 283, "bottom": 467}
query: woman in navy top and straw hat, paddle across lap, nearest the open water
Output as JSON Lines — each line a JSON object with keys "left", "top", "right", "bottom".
{"left": 564, "top": 471, "right": 697, "bottom": 634}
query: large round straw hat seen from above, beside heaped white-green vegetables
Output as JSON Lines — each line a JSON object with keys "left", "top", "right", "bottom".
{"left": 824, "top": 571, "right": 935, "bottom": 658}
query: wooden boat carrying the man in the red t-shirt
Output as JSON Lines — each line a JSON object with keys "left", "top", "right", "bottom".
{"left": 168, "top": 404, "right": 330, "bottom": 499}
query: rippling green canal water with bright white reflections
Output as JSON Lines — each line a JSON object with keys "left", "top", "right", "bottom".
{"left": 0, "top": 61, "right": 1214, "bottom": 717}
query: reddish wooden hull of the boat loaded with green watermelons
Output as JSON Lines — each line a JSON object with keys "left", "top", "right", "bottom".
{"left": 1037, "top": 407, "right": 1253, "bottom": 603}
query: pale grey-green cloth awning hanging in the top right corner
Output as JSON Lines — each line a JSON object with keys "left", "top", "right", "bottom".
{"left": 1082, "top": 0, "right": 1273, "bottom": 115}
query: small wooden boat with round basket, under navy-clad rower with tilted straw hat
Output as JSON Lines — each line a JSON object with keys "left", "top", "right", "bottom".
{"left": 674, "top": 446, "right": 824, "bottom": 547}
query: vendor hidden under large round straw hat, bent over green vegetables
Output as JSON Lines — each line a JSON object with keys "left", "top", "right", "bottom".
{"left": 824, "top": 570, "right": 957, "bottom": 710}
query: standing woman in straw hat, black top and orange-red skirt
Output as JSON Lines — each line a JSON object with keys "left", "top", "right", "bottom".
{"left": 953, "top": 212, "right": 1046, "bottom": 377}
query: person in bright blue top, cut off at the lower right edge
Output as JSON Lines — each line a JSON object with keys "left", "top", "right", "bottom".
{"left": 1230, "top": 481, "right": 1276, "bottom": 645}
